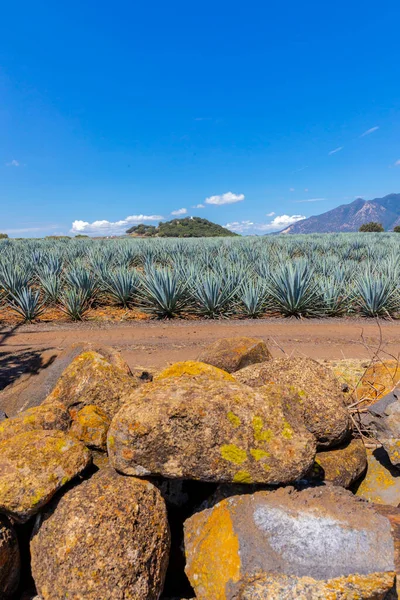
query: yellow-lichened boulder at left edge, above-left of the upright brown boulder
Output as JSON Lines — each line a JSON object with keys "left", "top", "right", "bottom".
{"left": 0, "top": 430, "right": 91, "bottom": 523}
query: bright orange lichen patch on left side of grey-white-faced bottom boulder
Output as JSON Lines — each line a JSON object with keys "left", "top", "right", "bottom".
{"left": 186, "top": 501, "right": 240, "bottom": 600}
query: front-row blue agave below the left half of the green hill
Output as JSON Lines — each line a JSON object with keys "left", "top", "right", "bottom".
{"left": 140, "top": 267, "right": 187, "bottom": 318}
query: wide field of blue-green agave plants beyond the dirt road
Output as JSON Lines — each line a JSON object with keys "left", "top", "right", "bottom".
{"left": 0, "top": 233, "right": 400, "bottom": 322}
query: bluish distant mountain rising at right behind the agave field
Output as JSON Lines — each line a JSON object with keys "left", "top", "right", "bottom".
{"left": 281, "top": 194, "right": 400, "bottom": 233}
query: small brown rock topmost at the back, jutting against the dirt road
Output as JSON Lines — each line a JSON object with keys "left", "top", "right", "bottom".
{"left": 197, "top": 337, "right": 272, "bottom": 373}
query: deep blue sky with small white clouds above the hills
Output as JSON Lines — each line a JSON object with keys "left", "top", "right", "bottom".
{"left": 0, "top": 0, "right": 400, "bottom": 237}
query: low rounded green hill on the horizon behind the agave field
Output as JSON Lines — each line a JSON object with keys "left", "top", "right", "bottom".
{"left": 126, "top": 217, "right": 237, "bottom": 237}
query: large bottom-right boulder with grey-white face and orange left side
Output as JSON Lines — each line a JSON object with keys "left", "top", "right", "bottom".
{"left": 185, "top": 486, "right": 395, "bottom": 600}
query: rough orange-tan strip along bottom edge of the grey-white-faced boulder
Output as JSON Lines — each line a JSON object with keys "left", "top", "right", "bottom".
{"left": 232, "top": 573, "right": 395, "bottom": 600}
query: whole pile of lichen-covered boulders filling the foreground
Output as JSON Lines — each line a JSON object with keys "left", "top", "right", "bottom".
{"left": 0, "top": 338, "right": 400, "bottom": 600}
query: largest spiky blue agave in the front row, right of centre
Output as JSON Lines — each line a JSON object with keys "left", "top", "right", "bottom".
{"left": 266, "top": 261, "right": 323, "bottom": 317}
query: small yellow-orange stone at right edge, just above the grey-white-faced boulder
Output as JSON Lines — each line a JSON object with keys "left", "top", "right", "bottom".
{"left": 356, "top": 448, "right": 400, "bottom": 506}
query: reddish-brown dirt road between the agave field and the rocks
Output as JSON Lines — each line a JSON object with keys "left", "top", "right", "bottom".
{"left": 0, "top": 319, "right": 400, "bottom": 390}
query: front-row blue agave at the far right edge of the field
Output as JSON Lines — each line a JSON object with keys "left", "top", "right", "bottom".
{"left": 353, "top": 272, "right": 400, "bottom": 317}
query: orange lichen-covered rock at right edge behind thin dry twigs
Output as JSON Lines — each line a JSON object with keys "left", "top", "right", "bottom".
{"left": 356, "top": 360, "right": 400, "bottom": 405}
